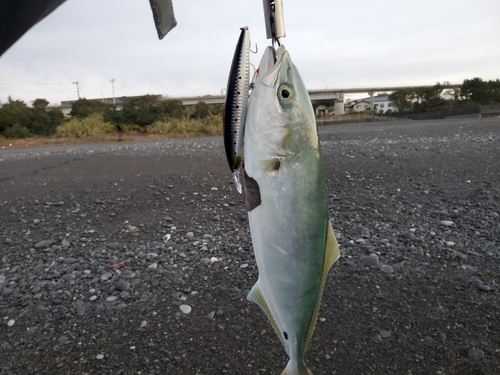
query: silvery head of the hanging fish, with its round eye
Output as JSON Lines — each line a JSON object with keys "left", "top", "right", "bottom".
{"left": 246, "top": 46, "right": 319, "bottom": 160}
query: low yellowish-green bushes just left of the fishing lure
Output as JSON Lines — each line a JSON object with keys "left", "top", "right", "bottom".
{"left": 146, "top": 115, "right": 222, "bottom": 137}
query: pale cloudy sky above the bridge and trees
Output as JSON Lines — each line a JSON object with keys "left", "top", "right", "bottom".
{"left": 0, "top": 0, "right": 500, "bottom": 105}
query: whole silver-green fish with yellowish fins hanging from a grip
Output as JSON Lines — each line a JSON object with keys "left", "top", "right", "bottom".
{"left": 244, "top": 45, "right": 339, "bottom": 375}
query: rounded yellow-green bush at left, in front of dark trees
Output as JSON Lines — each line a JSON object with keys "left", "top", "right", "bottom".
{"left": 56, "top": 114, "right": 115, "bottom": 138}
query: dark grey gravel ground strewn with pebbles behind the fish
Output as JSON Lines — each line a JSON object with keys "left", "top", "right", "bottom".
{"left": 0, "top": 119, "right": 500, "bottom": 375}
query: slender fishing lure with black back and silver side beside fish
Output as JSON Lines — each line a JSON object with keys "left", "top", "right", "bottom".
{"left": 223, "top": 27, "right": 250, "bottom": 194}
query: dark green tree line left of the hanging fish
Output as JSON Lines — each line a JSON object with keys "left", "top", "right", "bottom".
{"left": 0, "top": 95, "right": 222, "bottom": 138}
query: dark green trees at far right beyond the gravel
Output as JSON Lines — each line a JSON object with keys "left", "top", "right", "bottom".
{"left": 389, "top": 77, "right": 500, "bottom": 113}
